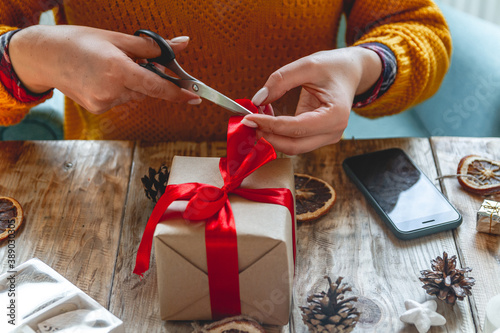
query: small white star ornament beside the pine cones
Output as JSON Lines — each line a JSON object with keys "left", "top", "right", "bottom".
{"left": 399, "top": 300, "right": 446, "bottom": 333}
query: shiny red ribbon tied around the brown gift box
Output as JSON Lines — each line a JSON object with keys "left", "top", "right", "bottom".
{"left": 134, "top": 100, "right": 295, "bottom": 320}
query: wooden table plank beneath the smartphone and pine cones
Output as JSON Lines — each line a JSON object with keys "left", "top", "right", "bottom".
{"left": 293, "top": 139, "right": 475, "bottom": 333}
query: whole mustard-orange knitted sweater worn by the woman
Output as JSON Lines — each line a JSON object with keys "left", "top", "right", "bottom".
{"left": 0, "top": 0, "right": 451, "bottom": 141}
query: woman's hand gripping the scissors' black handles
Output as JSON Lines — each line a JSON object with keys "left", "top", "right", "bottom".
{"left": 9, "top": 25, "right": 201, "bottom": 114}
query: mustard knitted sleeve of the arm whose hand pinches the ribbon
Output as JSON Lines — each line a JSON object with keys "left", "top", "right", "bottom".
{"left": 344, "top": 0, "right": 451, "bottom": 118}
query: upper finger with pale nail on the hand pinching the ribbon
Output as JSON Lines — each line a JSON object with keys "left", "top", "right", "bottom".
{"left": 252, "top": 58, "right": 310, "bottom": 106}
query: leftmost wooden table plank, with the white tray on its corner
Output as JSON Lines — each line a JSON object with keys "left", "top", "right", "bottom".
{"left": 0, "top": 141, "right": 134, "bottom": 307}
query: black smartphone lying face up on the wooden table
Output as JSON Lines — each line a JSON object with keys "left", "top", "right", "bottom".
{"left": 342, "top": 148, "right": 462, "bottom": 239}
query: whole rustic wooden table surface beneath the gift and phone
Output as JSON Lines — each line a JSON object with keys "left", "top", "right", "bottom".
{"left": 0, "top": 137, "right": 500, "bottom": 333}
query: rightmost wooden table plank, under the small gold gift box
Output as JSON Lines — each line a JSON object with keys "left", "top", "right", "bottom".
{"left": 431, "top": 137, "right": 500, "bottom": 332}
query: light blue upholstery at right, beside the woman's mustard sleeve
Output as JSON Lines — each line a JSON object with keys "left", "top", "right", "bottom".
{"left": 412, "top": 4, "right": 500, "bottom": 137}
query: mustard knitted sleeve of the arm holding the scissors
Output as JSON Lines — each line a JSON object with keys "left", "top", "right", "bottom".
{"left": 0, "top": 0, "right": 57, "bottom": 126}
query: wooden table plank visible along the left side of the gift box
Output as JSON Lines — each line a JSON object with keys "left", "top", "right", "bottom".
{"left": 110, "top": 142, "right": 282, "bottom": 333}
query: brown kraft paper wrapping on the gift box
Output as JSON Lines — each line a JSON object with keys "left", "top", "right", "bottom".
{"left": 154, "top": 156, "right": 295, "bottom": 325}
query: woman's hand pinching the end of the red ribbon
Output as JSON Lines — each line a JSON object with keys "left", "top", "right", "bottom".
{"left": 242, "top": 47, "right": 382, "bottom": 155}
